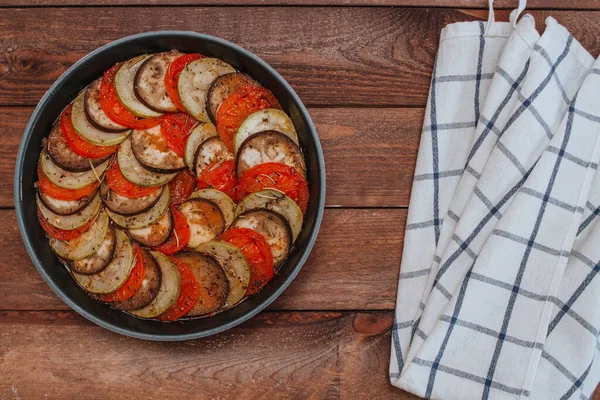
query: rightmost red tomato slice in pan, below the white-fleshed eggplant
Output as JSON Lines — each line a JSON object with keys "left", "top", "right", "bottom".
{"left": 237, "top": 163, "right": 308, "bottom": 213}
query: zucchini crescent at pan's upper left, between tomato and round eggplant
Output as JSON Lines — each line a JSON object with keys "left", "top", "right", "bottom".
{"left": 115, "top": 54, "right": 162, "bottom": 118}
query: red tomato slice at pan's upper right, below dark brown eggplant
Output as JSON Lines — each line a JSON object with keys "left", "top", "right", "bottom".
{"left": 217, "top": 86, "right": 281, "bottom": 151}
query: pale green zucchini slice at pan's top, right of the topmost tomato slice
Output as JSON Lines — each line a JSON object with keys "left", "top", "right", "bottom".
{"left": 177, "top": 57, "right": 235, "bottom": 122}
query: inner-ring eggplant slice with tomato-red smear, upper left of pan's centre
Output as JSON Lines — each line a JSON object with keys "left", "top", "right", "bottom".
{"left": 131, "top": 125, "right": 185, "bottom": 174}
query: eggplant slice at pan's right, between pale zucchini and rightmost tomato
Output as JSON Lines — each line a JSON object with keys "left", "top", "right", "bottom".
{"left": 236, "top": 131, "right": 306, "bottom": 179}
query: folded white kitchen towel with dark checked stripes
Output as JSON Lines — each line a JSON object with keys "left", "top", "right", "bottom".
{"left": 390, "top": 2, "right": 600, "bottom": 399}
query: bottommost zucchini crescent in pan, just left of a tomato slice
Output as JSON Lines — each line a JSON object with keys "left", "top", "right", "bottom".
{"left": 130, "top": 251, "right": 181, "bottom": 318}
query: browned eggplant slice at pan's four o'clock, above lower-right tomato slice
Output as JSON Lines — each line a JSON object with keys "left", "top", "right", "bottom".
{"left": 231, "top": 209, "right": 292, "bottom": 268}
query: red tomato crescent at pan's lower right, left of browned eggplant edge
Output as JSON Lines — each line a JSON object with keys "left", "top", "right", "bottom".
{"left": 221, "top": 228, "right": 275, "bottom": 295}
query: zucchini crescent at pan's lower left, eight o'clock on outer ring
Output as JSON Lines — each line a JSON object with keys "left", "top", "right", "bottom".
{"left": 49, "top": 212, "right": 110, "bottom": 261}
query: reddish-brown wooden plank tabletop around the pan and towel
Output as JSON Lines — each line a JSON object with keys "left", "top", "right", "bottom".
{"left": 0, "top": 0, "right": 600, "bottom": 399}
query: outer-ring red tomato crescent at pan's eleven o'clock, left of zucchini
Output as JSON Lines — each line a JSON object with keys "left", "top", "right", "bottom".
{"left": 98, "top": 63, "right": 162, "bottom": 129}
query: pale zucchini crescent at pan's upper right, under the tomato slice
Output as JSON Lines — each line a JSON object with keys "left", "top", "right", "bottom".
{"left": 233, "top": 108, "right": 300, "bottom": 154}
